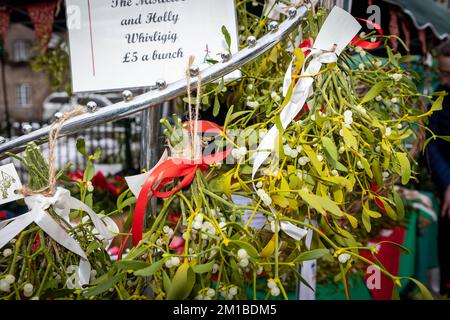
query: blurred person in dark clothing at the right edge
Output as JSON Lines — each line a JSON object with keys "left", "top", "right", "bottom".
{"left": 427, "top": 39, "right": 450, "bottom": 297}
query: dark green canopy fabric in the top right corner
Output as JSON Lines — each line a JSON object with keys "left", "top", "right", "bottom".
{"left": 384, "top": 0, "right": 450, "bottom": 39}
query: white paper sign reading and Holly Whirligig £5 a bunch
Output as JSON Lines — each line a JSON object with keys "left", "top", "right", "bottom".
{"left": 66, "top": 0, "right": 238, "bottom": 92}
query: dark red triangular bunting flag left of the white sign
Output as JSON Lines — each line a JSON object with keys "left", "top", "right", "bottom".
{"left": 28, "top": 1, "right": 57, "bottom": 50}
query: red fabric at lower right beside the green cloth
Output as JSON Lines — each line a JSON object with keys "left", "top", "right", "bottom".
{"left": 360, "top": 227, "right": 405, "bottom": 300}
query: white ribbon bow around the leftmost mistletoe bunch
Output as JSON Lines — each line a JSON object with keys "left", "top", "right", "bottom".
{"left": 0, "top": 188, "right": 119, "bottom": 288}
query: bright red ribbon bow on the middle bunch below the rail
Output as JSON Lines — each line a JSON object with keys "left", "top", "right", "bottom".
{"left": 125, "top": 121, "right": 230, "bottom": 246}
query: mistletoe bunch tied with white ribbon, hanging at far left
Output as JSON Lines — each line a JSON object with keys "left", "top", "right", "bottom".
{"left": 0, "top": 110, "right": 119, "bottom": 299}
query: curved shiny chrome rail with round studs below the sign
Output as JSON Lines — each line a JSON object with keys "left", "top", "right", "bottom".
{"left": 0, "top": 0, "right": 319, "bottom": 160}
